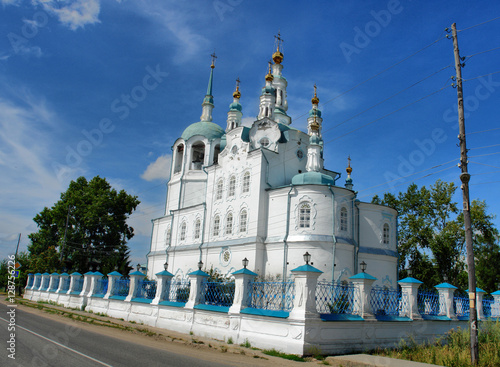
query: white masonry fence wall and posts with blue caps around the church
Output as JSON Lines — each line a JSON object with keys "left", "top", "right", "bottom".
{"left": 24, "top": 265, "right": 500, "bottom": 355}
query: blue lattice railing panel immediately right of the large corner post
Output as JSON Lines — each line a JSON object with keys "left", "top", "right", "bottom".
{"left": 316, "top": 281, "right": 360, "bottom": 314}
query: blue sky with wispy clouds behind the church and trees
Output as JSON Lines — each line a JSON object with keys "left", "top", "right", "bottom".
{"left": 0, "top": 0, "right": 500, "bottom": 263}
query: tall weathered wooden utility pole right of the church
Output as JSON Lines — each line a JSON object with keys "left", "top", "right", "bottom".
{"left": 451, "top": 23, "right": 479, "bottom": 366}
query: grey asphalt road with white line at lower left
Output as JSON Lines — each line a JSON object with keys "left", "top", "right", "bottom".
{"left": 0, "top": 304, "right": 227, "bottom": 367}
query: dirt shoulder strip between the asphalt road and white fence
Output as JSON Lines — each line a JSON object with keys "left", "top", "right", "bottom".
{"left": 0, "top": 293, "right": 329, "bottom": 367}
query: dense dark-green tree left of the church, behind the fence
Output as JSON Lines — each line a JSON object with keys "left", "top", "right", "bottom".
{"left": 28, "top": 176, "right": 140, "bottom": 273}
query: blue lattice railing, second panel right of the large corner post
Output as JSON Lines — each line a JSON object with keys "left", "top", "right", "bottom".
{"left": 370, "top": 286, "right": 408, "bottom": 316}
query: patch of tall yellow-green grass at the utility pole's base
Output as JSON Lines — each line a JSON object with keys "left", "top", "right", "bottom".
{"left": 372, "top": 321, "right": 500, "bottom": 367}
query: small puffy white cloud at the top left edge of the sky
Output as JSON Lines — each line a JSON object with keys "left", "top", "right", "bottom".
{"left": 35, "top": 0, "right": 101, "bottom": 31}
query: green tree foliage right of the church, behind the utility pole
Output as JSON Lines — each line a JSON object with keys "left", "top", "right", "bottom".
{"left": 372, "top": 180, "right": 500, "bottom": 292}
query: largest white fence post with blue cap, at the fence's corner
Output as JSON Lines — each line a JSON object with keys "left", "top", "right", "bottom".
{"left": 288, "top": 264, "right": 323, "bottom": 320}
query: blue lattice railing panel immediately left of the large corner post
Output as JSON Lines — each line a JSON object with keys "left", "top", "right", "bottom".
{"left": 248, "top": 282, "right": 295, "bottom": 312}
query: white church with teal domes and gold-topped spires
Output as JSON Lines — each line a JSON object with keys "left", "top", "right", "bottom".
{"left": 147, "top": 38, "right": 398, "bottom": 287}
